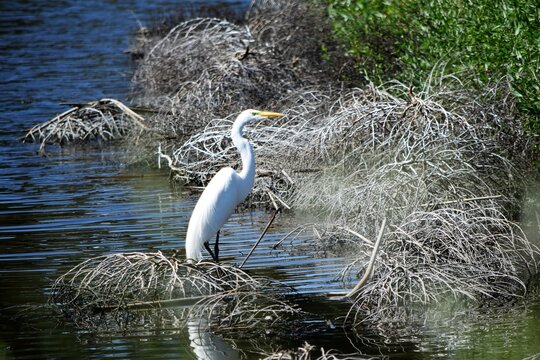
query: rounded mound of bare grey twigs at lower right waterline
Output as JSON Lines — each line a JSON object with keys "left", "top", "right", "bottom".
{"left": 340, "top": 206, "right": 540, "bottom": 322}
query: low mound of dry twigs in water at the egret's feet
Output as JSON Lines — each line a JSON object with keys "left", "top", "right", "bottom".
{"left": 51, "top": 252, "right": 299, "bottom": 330}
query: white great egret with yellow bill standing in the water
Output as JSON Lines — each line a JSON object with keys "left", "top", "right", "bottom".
{"left": 186, "top": 109, "right": 283, "bottom": 262}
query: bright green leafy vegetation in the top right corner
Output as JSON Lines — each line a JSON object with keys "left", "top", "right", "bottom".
{"left": 325, "top": 0, "right": 540, "bottom": 135}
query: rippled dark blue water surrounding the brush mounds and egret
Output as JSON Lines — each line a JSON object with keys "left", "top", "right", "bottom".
{"left": 0, "top": 0, "right": 540, "bottom": 359}
